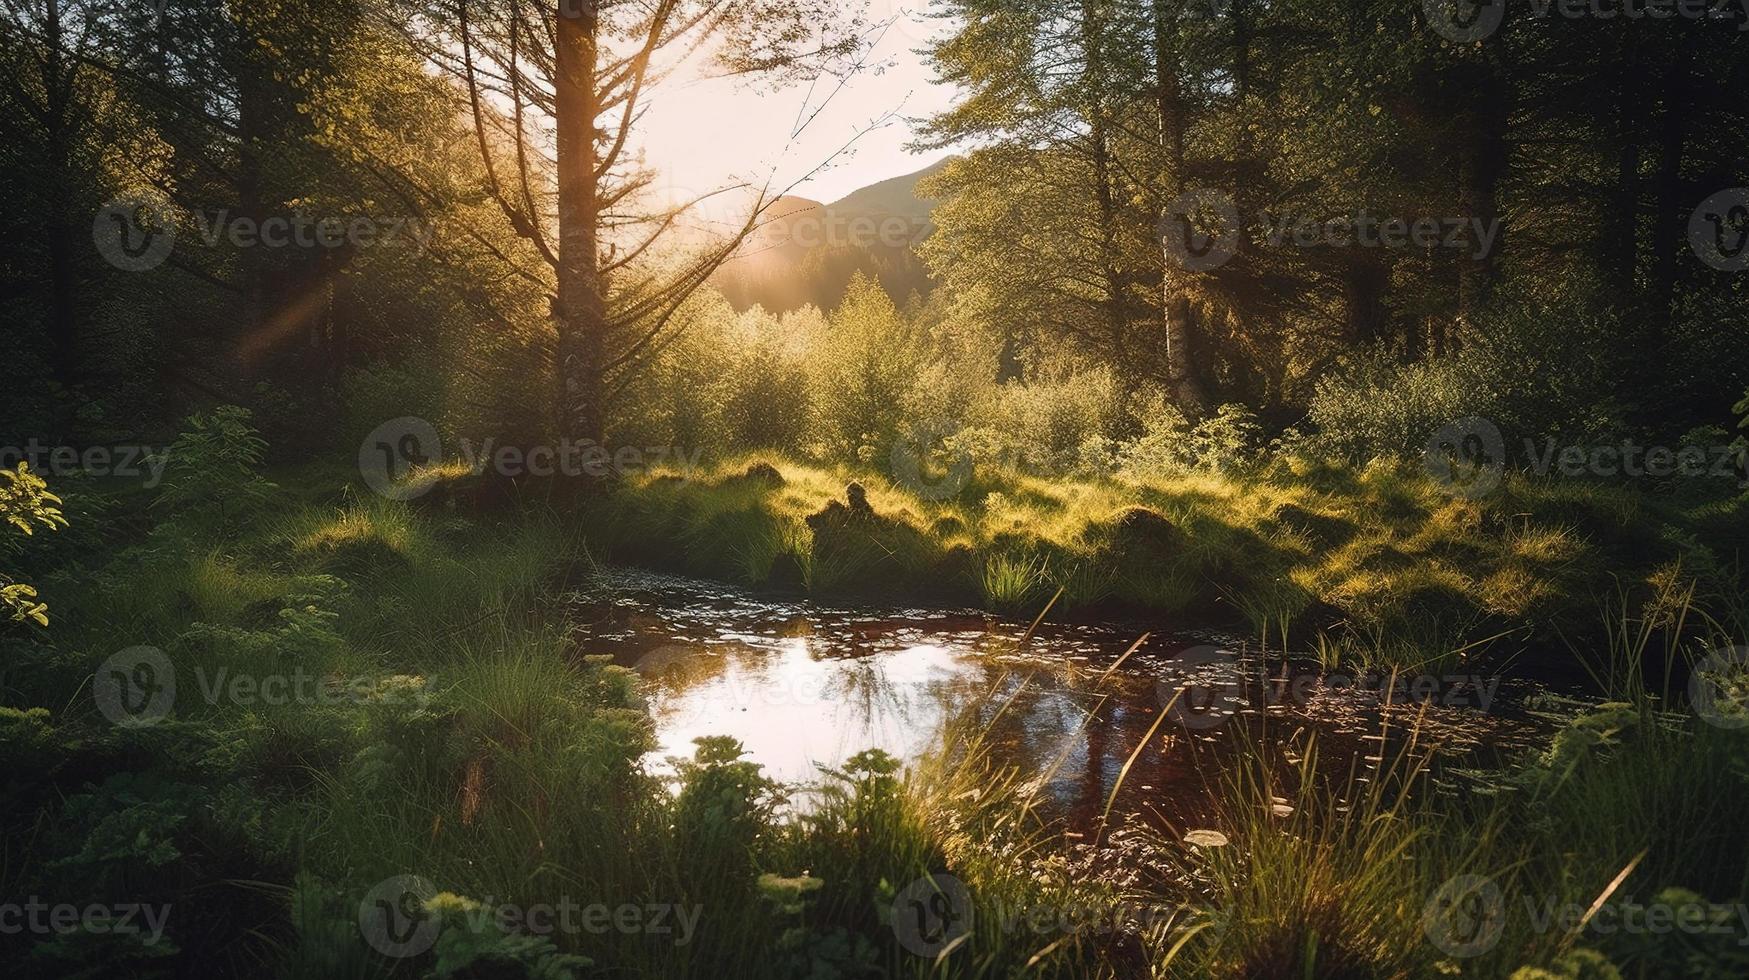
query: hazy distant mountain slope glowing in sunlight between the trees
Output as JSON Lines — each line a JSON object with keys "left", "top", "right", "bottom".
{"left": 715, "top": 161, "right": 948, "bottom": 313}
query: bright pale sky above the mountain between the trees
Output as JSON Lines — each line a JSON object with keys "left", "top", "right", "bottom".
{"left": 644, "top": 0, "right": 951, "bottom": 201}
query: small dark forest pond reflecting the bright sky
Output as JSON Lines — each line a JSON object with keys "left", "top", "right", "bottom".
{"left": 574, "top": 569, "right": 1550, "bottom": 835}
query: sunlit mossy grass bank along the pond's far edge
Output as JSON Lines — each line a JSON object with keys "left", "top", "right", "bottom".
{"left": 589, "top": 457, "right": 1726, "bottom": 663}
